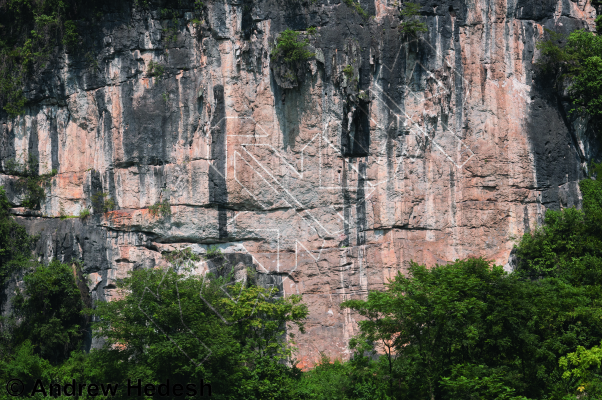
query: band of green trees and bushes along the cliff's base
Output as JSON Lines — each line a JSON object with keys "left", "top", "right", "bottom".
{"left": 0, "top": 179, "right": 602, "bottom": 400}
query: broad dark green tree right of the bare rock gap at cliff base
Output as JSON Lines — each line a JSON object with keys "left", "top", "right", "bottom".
{"left": 344, "top": 259, "right": 602, "bottom": 399}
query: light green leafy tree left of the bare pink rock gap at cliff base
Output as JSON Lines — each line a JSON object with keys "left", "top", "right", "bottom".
{"left": 90, "top": 254, "right": 307, "bottom": 399}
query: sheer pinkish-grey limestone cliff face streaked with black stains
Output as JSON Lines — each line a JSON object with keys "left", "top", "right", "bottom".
{"left": 0, "top": 0, "right": 598, "bottom": 366}
